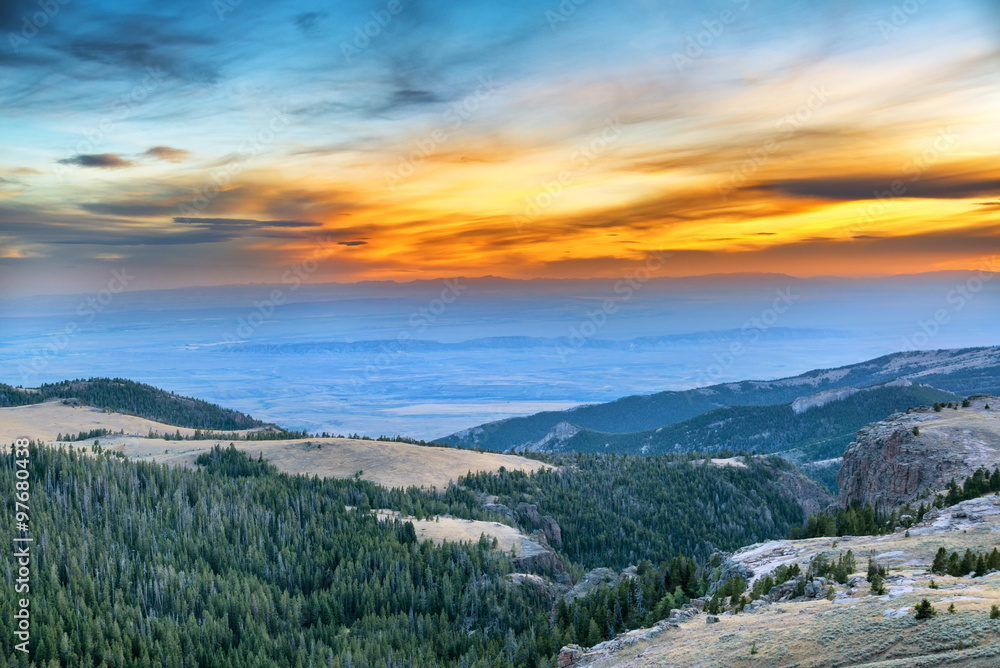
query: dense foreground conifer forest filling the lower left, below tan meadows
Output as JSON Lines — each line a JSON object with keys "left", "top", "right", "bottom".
{"left": 0, "top": 447, "right": 559, "bottom": 668}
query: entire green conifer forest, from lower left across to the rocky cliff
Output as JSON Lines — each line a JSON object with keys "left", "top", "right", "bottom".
{"left": 0, "top": 446, "right": 820, "bottom": 668}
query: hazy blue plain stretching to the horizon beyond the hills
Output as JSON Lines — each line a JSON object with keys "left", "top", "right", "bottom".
{"left": 0, "top": 272, "right": 1000, "bottom": 438}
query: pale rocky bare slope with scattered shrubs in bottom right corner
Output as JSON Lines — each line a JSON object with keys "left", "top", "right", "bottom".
{"left": 574, "top": 497, "right": 1000, "bottom": 668}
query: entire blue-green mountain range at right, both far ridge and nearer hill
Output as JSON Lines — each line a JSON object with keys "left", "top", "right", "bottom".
{"left": 437, "top": 347, "right": 1000, "bottom": 463}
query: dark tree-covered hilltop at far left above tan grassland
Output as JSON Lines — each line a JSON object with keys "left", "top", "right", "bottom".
{"left": 0, "top": 378, "right": 264, "bottom": 430}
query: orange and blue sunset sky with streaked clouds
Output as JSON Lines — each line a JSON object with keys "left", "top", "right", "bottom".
{"left": 0, "top": 0, "right": 1000, "bottom": 296}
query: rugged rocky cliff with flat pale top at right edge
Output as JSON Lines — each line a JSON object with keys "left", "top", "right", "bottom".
{"left": 837, "top": 395, "right": 1000, "bottom": 508}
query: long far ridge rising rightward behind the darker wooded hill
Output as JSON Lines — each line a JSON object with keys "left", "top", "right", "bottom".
{"left": 437, "top": 347, "right": 1000, "bottom": 451}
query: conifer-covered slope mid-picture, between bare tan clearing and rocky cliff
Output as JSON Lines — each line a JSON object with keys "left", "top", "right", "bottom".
{"left": 459, "top": 453, "right": 805, "bottom": 569}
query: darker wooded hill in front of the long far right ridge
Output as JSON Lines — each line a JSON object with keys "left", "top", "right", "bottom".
{"left": 558, "top": 384, "right": 961, "bottom": 462}
